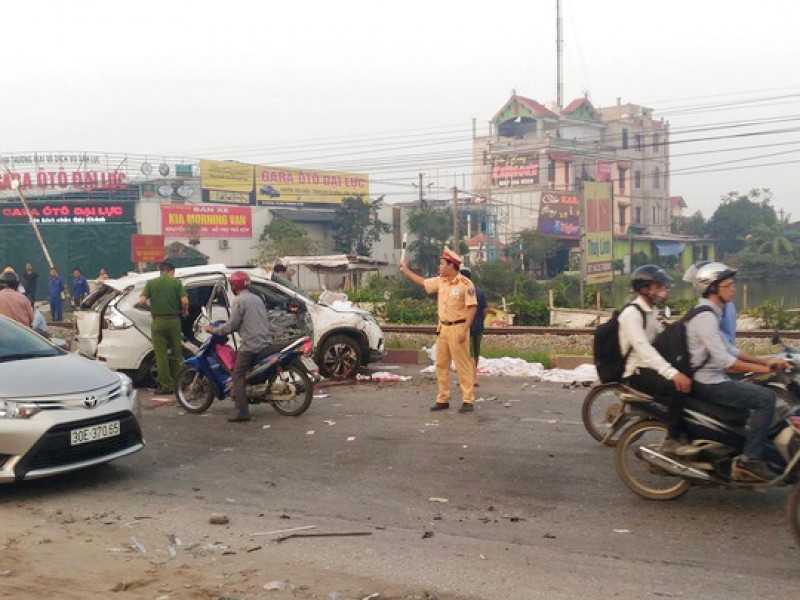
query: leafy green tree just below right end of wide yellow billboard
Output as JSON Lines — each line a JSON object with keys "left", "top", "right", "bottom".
{"left": 331, "top": 196, "right": 392, "bottom": 256}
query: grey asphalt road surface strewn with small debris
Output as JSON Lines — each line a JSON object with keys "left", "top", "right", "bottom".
{"left": 0, "top": 366, "right": 800, "bottom": 600}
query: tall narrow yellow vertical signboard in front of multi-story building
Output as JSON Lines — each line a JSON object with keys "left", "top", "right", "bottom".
{"left": 583, "top": 183, "right": 614, "bottom": 284}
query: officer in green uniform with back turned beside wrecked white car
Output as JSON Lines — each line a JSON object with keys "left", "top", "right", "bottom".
{"left": 139, "top": 261, "right": 189, "bottom": 394}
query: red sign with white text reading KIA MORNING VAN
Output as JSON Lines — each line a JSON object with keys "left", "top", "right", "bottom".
{"left": 161, "top": 204, "right": 253, "bottom": 238}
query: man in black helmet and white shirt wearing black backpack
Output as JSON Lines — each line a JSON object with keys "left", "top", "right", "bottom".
{"left": 619, "top": 265, "right": 692, "bottom": 453}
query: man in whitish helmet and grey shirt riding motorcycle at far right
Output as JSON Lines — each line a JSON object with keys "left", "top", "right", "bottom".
{"left": 686, "top": 262, "right": 789, "bottom": 481}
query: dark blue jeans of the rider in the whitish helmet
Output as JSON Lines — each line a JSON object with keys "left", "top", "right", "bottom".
{"left": 692, "top": 381, "right": 775, "bottom": 458}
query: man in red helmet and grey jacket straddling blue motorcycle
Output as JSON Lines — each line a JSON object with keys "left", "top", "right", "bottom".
{"left": 205, "top": 271, "right": 272, "bottom": 423}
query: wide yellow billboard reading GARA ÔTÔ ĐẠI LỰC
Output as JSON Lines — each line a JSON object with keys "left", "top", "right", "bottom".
{"left": 255, "top": 166, "right": 369, "bottom": 206}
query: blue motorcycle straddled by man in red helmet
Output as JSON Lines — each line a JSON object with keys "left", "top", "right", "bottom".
{"left": 175, "top": 321, "right": 318, "bottom": 417}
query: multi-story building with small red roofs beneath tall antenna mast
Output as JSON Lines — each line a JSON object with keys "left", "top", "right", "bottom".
{"left": 473, "top": 94, "right": 670, "bottom": 242}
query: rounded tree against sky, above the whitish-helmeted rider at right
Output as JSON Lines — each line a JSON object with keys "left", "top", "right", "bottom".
{"left": 708, "top": 189, "right": 777, "bottom": 254}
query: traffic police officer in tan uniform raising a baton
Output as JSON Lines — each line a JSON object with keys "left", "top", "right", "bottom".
{"left": 400, "top": 248, "right": 478, "bottom": 413}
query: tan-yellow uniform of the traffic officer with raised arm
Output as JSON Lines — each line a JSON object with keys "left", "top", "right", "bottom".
{"left": 424, "top": 275, "right": 478, "bottom": 404}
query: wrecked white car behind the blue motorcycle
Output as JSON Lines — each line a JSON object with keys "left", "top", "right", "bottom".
{"left": 76, "top": 265, "right": 386, "bottom": 386}
